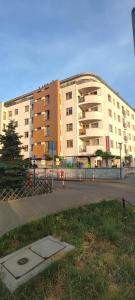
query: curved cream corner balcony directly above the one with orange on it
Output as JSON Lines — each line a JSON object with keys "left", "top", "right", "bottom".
{"left": 79, "top": 111, "right": 103, "bottom": 122}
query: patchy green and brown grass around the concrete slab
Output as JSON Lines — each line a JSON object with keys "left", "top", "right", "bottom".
{"left": 0, "top": 201, "right": 135, "bottom": 300}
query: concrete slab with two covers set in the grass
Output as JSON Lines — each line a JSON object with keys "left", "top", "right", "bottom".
{"left": 0, "top": 236, "right": 74, "bottom": 292}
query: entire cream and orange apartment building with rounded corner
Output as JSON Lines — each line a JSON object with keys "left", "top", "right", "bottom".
{"left": 0, "top": 73, "right": 135, "bottom": 164}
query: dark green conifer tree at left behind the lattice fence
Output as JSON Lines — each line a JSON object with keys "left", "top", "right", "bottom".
{"left": 0, "top": 121, "right": 27, "bottom": 189}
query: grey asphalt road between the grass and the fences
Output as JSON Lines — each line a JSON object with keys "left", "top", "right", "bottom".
{"left": 0, "top": 175, "right": 135, "bottom": 236}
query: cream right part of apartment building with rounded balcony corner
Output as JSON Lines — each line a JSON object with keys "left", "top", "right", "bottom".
{"left": 61, "top": 73, "right": 135, "bottom": 165}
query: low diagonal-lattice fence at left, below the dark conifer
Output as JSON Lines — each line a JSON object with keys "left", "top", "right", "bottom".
{"left": 0, "top": 179, "right": 52, "bottom": 201}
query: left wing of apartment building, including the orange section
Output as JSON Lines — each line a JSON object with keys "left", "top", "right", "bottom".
{"left": 0, "top": 81, "right": 60, "bottom": 159}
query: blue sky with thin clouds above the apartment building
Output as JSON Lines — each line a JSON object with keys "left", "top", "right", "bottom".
{"left": 0, "top": 0, "right": 135, "bottom": 107}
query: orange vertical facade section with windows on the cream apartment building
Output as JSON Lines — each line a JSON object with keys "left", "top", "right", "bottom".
{"left": 33, "top": 81, "right": 60, "bottom": 158}
